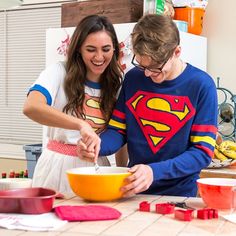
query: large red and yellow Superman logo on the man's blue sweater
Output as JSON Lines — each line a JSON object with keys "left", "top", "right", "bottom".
{"left": 126, "top": 91, "right": 195, "bottom": 154}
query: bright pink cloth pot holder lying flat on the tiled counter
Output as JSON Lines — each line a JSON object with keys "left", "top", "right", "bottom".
{"left": 54, "top": 205, "right": 121, "bottom": 221}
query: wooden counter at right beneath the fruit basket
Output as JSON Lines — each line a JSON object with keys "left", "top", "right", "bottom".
{"left": 200, "top": 165, "right": 236, "bottom": 179}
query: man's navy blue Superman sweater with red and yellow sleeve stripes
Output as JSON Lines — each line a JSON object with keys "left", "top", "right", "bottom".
{"left": 100, "top": 64, "right": 217, "bottom": 196}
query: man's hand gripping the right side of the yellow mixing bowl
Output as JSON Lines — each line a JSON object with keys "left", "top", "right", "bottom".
{"left": 121, "top": 164, "right": 153, "bottom": 197}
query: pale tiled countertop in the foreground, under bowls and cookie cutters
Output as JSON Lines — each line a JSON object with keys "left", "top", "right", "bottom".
{"left": 0, "top": 195, "right": 236, "bottom": 236}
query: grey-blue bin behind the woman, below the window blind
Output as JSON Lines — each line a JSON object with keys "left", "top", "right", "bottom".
{"left": 23, "top": 144, "right": 42, "bottom": 178}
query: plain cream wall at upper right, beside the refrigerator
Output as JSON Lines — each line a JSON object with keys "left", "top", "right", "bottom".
{"left": 202, "top": 0, "right": 236, "bottom": 94}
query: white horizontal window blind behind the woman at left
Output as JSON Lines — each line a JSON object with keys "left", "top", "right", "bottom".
{"left": 0, "top": 5, "right": 61, "bottom": 157}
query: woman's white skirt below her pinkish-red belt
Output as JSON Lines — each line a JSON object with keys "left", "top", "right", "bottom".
{"left": 32, "top": 148, "right": 110, "bottom": 195}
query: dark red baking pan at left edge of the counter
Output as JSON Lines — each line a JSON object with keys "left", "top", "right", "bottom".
{"left": 0, "top": 188, "right": 56, "bottom": 214}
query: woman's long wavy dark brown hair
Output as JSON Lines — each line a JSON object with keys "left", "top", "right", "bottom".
{"left": 63, "top": 15, "right": 122, "bottom": 124}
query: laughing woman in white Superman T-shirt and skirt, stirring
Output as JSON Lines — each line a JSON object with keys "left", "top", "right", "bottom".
{"left": 23, "top": 15, "right": 122, "bottom": 193}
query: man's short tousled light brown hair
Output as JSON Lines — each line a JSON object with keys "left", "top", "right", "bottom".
{"left": 131, "top": 14, "right": 180, "bottom": 63}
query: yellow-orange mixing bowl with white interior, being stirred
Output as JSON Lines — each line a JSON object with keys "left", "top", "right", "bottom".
{"left": 66, "top": 166, "right": 131, "bottom": 201}
